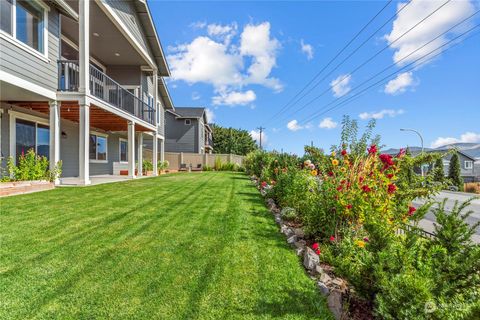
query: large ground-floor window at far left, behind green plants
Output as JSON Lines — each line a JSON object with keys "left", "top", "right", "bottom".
{"left": 15, "top": 119, "right": 50, "bottom": 160}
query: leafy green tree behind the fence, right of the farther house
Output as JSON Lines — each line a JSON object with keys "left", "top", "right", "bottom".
{"left": 212, "top": 125, "right": 257, "bottom": 155}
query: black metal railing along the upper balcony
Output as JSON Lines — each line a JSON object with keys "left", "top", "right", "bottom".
{"left": 58, "top": 60, "right": 156, "bottom": 125}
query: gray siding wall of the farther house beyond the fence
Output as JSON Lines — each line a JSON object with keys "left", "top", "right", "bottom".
{"left": 165, "top": 112, "right": 199, "bottom": 153}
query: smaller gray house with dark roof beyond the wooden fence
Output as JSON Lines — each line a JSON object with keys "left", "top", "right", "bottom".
{"left": 165, "top": 108, "right": 213, "bottom": 154}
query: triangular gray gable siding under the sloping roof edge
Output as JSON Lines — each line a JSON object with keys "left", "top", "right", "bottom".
{"left": 105, "top": 0, "right": 152, "bottom": 56}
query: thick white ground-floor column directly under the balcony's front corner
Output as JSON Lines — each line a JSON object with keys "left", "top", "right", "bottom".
{"left": 78, "top": 104, "right": 90, "bottom": 184}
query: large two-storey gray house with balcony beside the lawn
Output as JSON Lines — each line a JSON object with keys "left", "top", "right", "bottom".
{"left": 0, "top": 0, "right": 173, "bottom": 184}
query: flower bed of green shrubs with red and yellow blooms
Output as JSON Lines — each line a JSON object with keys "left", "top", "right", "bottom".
{"left": 246, "top": 118, "right": 480, "bottom": 319}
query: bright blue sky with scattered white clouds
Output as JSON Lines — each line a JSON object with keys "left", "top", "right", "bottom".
{"left": 149, "top": 0, "right": 480, "bottom": 154}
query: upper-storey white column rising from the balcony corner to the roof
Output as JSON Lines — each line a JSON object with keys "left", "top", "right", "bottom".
{"left": 78, "top": 0, "right": 90, "bottom": 94}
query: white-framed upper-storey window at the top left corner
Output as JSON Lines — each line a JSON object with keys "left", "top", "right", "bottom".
{"left": 0, "top": 0, "right": 46, "bottom": 54}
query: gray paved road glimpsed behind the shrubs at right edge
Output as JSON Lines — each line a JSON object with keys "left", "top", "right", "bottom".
{"left": 413, "top": 191, "right": 480, "bottom": 243}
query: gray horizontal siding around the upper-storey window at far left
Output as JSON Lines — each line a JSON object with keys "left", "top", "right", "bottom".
{"left": 0, "top": 7, "right": 60, "bottom": 91}
